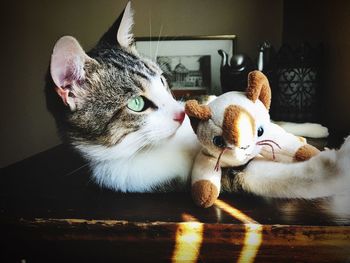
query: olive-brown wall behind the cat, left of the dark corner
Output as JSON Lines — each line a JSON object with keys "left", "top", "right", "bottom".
{"left": 0, "top": 0, "right": 283, "bottom": 167}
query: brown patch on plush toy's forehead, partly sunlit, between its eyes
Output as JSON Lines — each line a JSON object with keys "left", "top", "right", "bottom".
{"left": 223, "top": 105, "right": 255, "bottom": 147}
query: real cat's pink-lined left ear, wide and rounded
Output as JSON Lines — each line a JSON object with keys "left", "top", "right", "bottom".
{"left": 50, "top": 36, "right": 94, "bottom": 110}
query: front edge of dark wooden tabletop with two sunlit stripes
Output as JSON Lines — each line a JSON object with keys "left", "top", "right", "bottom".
{"left": 0, "top": 218, "right": 350, "bottom": 262}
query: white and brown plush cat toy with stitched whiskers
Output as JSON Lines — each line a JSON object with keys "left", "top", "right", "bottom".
{"left": 185, "top": 71, "right": 319, "bottom": 207}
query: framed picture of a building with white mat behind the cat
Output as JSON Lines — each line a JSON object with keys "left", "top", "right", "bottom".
{"left": 136, "top": 35, "right": 236, "bottom": 97}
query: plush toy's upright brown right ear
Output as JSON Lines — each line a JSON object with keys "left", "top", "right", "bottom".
{"left": 246, "top": 70, "right": 271, "bottom": 110}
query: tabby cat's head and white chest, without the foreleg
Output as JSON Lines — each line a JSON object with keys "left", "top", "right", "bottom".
{"left": 46, "top": 3, "right": 199, "bottom": 192}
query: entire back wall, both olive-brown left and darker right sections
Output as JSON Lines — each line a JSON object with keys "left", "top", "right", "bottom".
{"left": 0, "top": 0, "right": 350, "bottom": 167}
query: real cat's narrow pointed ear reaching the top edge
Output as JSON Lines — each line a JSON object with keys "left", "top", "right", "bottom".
{"left": 99, "top": 1, "right": 134, "bottom": 48}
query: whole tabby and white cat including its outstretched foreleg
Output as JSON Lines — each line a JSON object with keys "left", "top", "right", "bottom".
{"left": 46, "top": 2, "right": 350, "bottom": 198}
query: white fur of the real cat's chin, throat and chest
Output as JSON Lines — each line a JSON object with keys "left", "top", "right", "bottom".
{"left": 75, "top": 118, "right": 199, "bottom": 192}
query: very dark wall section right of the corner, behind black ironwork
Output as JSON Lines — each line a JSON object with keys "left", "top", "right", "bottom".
{"left": 282, "top": 0, "right": 350, "bottom": 135}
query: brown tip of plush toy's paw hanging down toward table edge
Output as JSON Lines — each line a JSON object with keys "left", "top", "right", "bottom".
{"left": 192, "top": 180, "right": 219, "bottom": 208}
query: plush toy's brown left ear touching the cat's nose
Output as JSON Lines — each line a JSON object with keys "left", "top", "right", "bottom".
{"left": 185, "top": 100, "right": 212, "bottom": 133}
